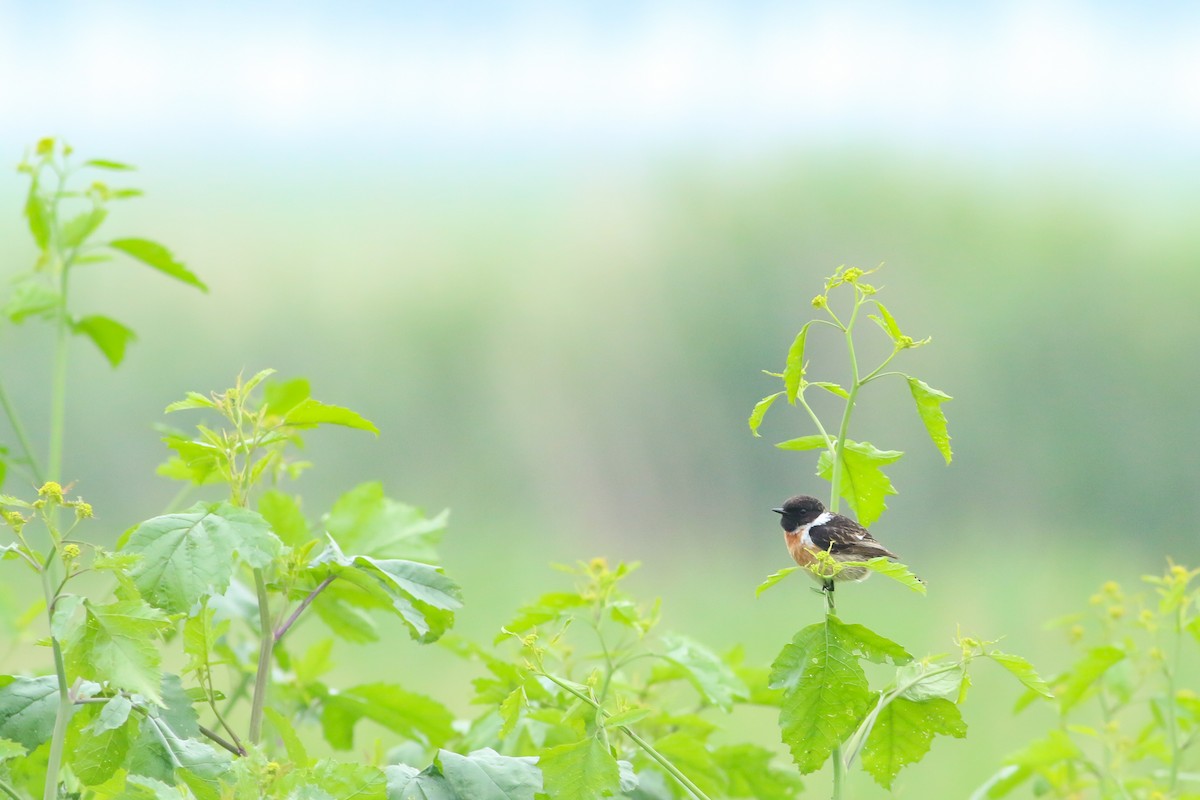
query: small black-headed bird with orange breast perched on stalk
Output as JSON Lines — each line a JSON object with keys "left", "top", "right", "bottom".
{"left": 772, "top": 494, "right": 900, "bottom": 591}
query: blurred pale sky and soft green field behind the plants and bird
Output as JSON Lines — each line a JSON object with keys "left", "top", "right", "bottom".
{"left": 0, "top": 2, "right": 1200, "bottom": 798}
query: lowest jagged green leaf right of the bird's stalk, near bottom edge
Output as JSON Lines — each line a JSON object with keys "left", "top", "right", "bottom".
{"left": 863, "top": 697, "right": 967, "bottom": 789}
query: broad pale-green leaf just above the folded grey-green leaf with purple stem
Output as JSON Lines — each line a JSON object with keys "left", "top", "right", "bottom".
{"left": 323, "top": 482, "right": 450, "bottom": 564}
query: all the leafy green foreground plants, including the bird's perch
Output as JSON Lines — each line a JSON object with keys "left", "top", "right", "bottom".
{"left": 0, "top": 140, "right": 1185, "bottom": 800}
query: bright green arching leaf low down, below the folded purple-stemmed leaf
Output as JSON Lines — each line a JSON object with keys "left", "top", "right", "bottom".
{"left": 320, "top": 684, "right": 454, "bottom": 750}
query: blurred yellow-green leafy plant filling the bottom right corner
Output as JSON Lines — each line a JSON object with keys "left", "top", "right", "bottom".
{"left": 974, "top": 564, "right": 1200, "bottom": 800}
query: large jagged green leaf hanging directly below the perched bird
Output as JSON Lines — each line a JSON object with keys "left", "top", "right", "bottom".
{"left": 770, "top": 615, "right": 882, "bottom": 774}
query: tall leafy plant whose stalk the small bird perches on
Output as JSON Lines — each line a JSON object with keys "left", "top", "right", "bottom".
{"left": 749, "top": 267, "right": 1048, "bottom": 800}
